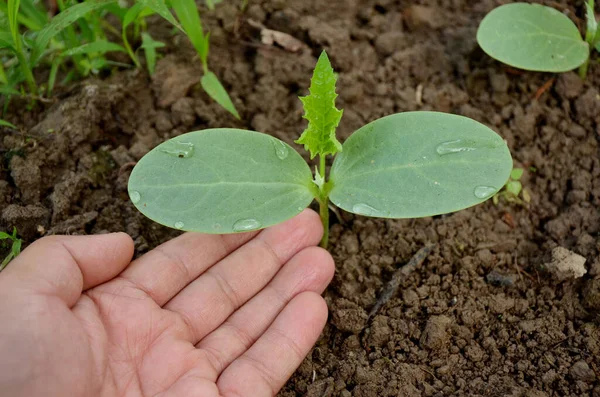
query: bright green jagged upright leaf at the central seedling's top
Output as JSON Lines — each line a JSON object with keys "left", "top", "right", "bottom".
{"left": 296, "top": 51, "right": 343, "bottom": 159}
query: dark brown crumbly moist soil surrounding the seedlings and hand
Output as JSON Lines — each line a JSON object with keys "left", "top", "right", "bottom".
{"left": 0, "top": 0, "right": 600, "bottom": 397}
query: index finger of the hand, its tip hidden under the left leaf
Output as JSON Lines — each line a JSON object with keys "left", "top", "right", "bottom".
{"left": 119, "top": 232, "right": 258, "bottom": 306}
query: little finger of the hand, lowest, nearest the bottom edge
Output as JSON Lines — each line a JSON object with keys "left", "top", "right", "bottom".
{"left": 217, "top": 292, "right": 327, "bottom": 397}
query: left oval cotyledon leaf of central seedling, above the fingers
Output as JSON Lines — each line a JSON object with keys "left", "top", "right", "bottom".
{"left": 128, "top": 128, "right": 315, "bottom": 234}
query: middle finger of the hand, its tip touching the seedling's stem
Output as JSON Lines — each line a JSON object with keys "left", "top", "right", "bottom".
{"left": 164, "top": 210, "right": 323, "bottom": 343}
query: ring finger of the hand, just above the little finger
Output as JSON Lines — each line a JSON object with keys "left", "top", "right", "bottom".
{"left": 197, "top": 247, "right": 335, "bottom": 373}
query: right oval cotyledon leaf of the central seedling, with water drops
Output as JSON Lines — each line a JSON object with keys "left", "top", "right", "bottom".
{"left": 329, "top": 112, "right": 512, "bottom": 218}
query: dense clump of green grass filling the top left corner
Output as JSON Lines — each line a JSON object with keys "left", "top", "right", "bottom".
{"left": 0, "top": 0, "right": 125, "bottom": 97}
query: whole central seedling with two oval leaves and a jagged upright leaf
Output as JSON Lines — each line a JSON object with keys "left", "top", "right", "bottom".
{"left": 128, "top": 52, "right": 512, "bottom": 246}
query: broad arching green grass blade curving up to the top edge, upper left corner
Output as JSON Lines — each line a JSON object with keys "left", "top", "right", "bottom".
{"left": 32, "top": 0, "right": 116, "bottom": 65}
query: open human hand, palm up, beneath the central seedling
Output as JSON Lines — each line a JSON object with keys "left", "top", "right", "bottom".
{"left": 0, "top": 210, "right": 334, "bottom": 397}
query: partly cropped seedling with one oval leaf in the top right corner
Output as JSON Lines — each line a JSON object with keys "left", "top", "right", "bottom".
{"left": 477, "top": 0, "right": 600, "bottom": 78}
